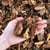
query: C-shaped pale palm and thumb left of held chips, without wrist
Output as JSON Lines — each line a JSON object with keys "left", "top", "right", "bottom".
{"left": 2, "top": 17, "right": 25, "bottom": 45}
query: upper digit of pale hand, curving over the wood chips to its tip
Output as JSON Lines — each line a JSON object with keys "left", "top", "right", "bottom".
{"left": 3, "top": 17, "right": 23, "bottom": 35}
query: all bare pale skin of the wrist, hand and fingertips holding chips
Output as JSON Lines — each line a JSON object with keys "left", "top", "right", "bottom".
{"left": 0, "top": 17, "right": 47, "bottom": 50}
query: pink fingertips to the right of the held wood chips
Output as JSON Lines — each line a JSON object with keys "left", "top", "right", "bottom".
{"left": 35, "top": 18, "right": 47, "bottom": 35}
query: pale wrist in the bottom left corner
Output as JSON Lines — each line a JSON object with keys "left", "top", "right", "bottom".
{"left": 0, "top": 37, "right": 10, "bottom": 50}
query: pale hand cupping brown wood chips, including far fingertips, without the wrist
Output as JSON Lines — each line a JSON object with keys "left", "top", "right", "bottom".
{"left": 0, "top": 17, "right": 46, "bottom": 48}
